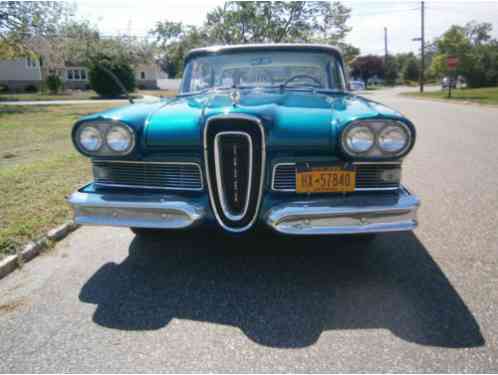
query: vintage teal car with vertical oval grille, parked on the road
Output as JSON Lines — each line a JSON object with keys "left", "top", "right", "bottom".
{"left": 68, "top": 44, "right": 419, "bottom": 235}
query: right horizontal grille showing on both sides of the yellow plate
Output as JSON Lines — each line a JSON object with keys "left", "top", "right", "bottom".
{"left": 272, "top": 163, "right": 401, "bottom": 192}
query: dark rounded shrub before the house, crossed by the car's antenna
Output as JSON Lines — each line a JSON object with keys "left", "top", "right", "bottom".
{"left": 89, "top": 58, "right": 136, "bottom": 97}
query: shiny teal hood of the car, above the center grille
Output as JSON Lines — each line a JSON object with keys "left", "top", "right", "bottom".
{"left": 91, "top": 91, "right": 402, "bottom": 152}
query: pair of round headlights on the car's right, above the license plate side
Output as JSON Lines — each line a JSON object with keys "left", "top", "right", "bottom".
{"left": 341, "top": 120, "right": 413, "bottom": 158}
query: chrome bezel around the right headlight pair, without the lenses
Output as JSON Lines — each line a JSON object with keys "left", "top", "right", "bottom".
{"left": 340, "top": 119, "right": 415, "bottom": 159}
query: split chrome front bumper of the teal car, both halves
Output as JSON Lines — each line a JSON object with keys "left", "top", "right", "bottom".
{"left": 68, "top": 187, "right": 420, "bottom": 235}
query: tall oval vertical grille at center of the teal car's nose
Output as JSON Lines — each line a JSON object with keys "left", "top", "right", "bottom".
{"left": 204, "top": 114, "right": 265, "bottom": 232}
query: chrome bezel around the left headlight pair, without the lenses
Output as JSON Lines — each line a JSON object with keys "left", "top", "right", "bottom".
{"left": 72, "top": 120, "right": 136, "bottom": 157}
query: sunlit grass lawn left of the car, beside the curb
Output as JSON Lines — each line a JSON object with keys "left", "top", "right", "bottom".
{"left": 0, "top": 103, "right": 120, "bottom": 258}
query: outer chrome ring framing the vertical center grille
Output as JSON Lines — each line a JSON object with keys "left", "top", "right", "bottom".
{"left": 203, "top": 113, "right": 266, "bottom": 233}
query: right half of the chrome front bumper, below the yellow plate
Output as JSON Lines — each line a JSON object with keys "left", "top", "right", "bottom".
{"left": 265, "top": 187, "right": 420, "bottom": 235}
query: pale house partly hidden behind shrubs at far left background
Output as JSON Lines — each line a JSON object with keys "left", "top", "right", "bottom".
{"left": 0, "top": 57, "right": 164, "bottom": 91}
